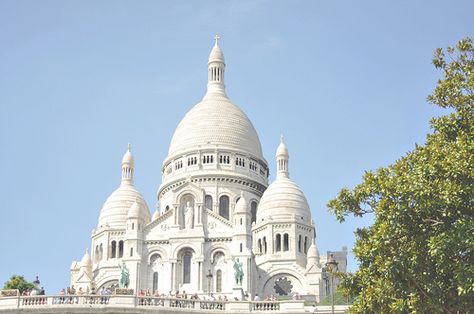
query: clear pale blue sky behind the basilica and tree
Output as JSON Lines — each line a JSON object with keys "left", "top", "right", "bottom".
{"left": 0, "top": 0, "right": 474, "bottom": 293}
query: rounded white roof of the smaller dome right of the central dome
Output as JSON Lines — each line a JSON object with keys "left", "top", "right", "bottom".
{"left": 257, "top": 178, "right": 311, "bottom": 223}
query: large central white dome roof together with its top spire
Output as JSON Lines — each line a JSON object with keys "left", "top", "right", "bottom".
{"left": 168, "top": 39, "right": 264, "bottom": 160}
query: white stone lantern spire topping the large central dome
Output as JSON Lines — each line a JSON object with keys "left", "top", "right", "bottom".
{"left": 206, "top": 35, "right": 225, "bottom": 96}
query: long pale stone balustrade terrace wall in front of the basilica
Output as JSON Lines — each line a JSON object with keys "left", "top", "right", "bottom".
{"left": 0, "top": 295, "right": 348, "bottom": 314}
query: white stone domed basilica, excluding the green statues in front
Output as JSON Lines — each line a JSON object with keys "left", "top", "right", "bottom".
{"left": 71, "top": 40, "right": 347, "bottom": 300}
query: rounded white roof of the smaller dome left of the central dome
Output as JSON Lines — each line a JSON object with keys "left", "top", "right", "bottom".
{"left": 98, "top": 184, "right": 150, "bottom": 228}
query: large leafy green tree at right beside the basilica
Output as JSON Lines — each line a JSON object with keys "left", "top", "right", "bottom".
{"left": 328, "top": 38, "right": 474, "bottom": 313}
